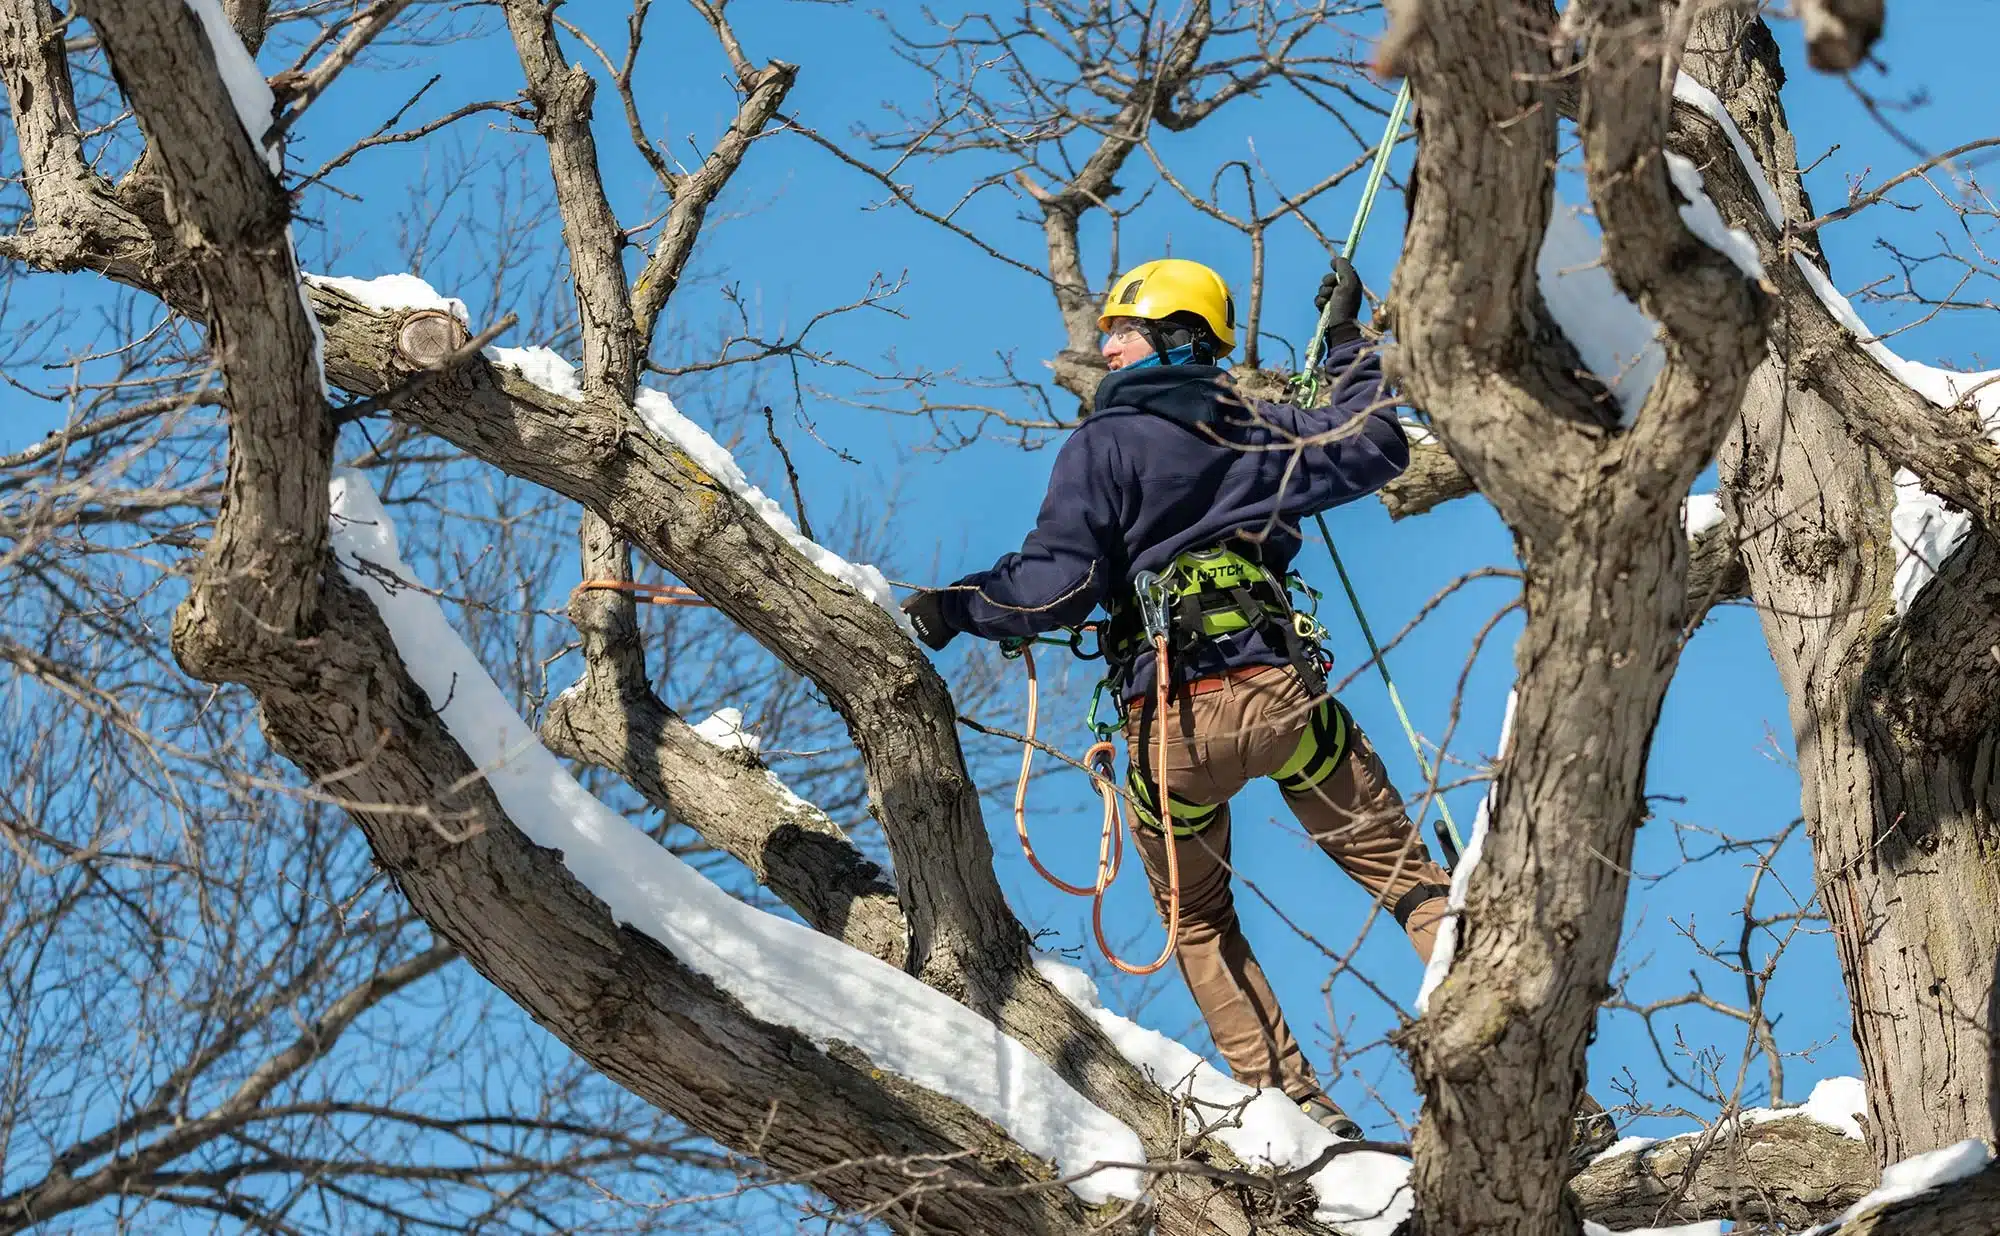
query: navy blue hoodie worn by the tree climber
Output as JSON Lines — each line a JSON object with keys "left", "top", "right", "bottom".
{"left": 944, "top": 338, "right": 1410, "bottom": 700}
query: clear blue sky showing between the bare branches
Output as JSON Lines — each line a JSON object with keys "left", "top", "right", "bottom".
{"left": 0, "top": 0, "right": 1996, "bottom": 1224}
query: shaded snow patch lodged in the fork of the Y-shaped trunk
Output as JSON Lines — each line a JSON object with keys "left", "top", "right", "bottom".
{"left": 1534, "top": 198, "right": 1666, "bottom": 424}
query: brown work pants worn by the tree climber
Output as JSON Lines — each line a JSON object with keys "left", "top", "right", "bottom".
{"left": 1126, "top": 668, "right": 1450, "bottom": 1098}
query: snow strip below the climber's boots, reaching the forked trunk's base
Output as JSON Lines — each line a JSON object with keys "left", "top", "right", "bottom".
{"left": 1034, "top": 956, "right": 1412, "bottom": 1236}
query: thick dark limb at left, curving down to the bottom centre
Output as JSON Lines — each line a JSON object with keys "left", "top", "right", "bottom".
{"left": 39, "top": 0, "right": 1166, "bottom": 1232}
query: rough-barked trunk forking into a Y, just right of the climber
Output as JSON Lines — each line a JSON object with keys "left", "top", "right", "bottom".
{"left": 1392, "top": 0, "right": 1764, "bottom": 1236}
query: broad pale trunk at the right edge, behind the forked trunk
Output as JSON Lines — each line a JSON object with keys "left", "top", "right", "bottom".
{"left": 1686, "top": 12, "right": 2000, "bottom": 1162}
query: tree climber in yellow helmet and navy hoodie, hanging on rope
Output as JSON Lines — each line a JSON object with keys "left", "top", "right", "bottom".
{"left": 904, "top": 258, "right": 1450, "bottom": 1138}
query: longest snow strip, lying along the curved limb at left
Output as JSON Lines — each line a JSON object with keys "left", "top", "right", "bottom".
{"left": 330, "top": 470, "right": 1144, "bottom": 1202}
